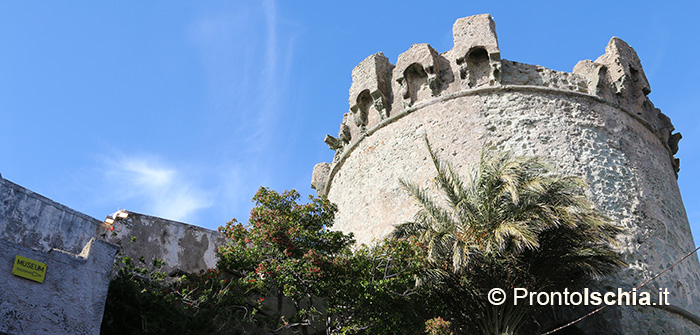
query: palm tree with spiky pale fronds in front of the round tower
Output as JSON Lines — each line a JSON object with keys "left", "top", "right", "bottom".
{"left": 392, "top": 137, "right": 624, "bottom": 334}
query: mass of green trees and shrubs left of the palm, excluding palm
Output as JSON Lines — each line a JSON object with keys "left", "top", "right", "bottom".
{"left": 102, "top": 188, "right": 437, "bottom": 334}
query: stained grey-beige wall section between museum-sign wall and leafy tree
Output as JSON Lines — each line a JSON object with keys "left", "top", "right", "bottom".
{"left": 106, "top": 212, "right": 223, "bottom": 275}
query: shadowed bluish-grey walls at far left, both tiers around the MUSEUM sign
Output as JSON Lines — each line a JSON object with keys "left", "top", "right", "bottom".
{"left": 0, "top": 177, "right": 117, "bottom": 334}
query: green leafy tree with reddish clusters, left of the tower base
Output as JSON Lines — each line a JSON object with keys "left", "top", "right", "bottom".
{"left": 218, "top": 188, "right": 353, "bottom": 334}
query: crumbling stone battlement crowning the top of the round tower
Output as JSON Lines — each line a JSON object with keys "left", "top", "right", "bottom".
{"left": 312, "top": 14, "right": 681, "bottom": 194}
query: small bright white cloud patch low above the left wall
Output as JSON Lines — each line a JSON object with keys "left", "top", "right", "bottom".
{"left": 105, "top": 156, "right": 213, "bottom": 221}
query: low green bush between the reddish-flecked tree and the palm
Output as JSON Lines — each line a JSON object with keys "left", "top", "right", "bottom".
{"left": 324, "top": 238, "right": 436, "bottom": 334}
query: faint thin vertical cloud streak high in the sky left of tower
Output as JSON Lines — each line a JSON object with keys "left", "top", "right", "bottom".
{"left": 190, "top": 0, "right": 294, "bottom": 155}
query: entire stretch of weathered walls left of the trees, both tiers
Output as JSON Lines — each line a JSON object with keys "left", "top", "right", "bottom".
{"left": 0, "top": 177, "right": 223, "bottom": 335}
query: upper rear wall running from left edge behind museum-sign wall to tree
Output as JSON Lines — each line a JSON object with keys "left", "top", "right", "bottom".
{"left": 0, "top": 178, "right": 223, "bottom": 272}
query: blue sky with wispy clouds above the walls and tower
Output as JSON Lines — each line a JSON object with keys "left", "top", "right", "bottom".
{"left": 0, "top": 0, "right": 700, "bottom": 244}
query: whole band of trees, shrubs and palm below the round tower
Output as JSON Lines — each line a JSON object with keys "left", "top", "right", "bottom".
{"left": 102, "top": 146, "right": 622, "bottom": 334}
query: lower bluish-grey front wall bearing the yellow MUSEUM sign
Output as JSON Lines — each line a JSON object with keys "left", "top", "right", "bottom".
{"left": 0, "top": 239, "right": 117, "bottom": 335}
